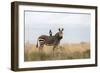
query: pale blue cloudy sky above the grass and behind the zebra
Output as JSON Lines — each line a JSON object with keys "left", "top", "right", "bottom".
{"left": 25, "top": 11, "right": 91, "bottom": 44}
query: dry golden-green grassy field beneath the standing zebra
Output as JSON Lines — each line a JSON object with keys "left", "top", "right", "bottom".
{"left": 24, "top": 42, "right": 90, "bottom": 61}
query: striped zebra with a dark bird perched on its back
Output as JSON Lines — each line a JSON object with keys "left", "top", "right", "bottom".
{"left": 36, "top": 28, "right": 64, "bottom": 52}
